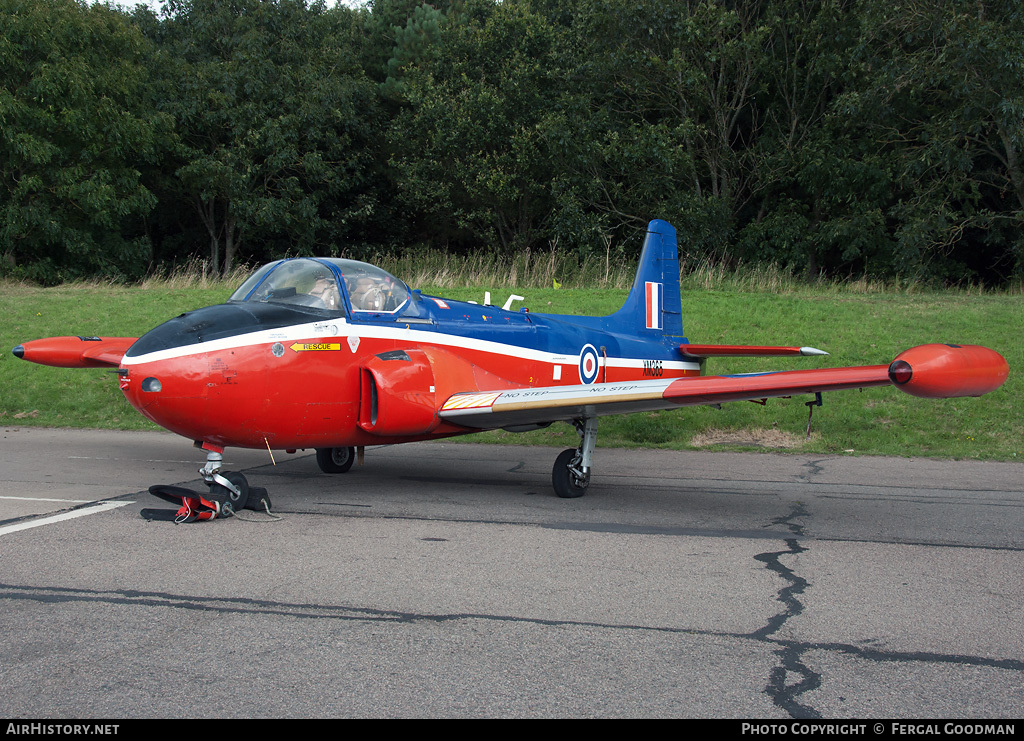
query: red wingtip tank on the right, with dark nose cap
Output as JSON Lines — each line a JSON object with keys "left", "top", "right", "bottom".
{"left": 889, "top": 344, "right": 1010, "bottom": 399}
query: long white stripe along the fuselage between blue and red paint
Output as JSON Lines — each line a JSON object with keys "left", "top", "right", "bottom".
{"left": 121, "top": 318, "right": 700, "bottom": 371}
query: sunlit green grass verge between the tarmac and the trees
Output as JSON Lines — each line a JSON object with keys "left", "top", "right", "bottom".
{"left": 0, "top": 274, "right": 1024, "bottom": 461}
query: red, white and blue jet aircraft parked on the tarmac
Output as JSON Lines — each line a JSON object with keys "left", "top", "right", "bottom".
{"left": 13, "top": 220, "right": 1009, "bottom": 514}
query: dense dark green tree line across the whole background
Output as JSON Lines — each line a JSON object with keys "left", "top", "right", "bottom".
{"left": 0, "top": 0, "right": 1024, "bottom": 284}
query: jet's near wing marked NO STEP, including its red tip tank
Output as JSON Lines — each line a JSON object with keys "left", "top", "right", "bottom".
{"left": 439, "top": 345, "right": 1009, "bottom": 429}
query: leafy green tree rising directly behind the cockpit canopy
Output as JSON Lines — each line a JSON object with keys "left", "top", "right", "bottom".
{"left": 147, "top": 0, "right": 380, "bottom": 272}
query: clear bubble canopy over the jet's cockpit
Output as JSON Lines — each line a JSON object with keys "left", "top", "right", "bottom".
{"left": 228, "top": 257, "right": 410, "bottom": 314}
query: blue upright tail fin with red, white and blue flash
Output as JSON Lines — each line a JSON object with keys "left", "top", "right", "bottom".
{"left": 612, "top": 219, "right": 683, "bottom": 338}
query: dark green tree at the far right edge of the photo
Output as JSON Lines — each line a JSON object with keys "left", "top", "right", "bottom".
{"left": 837, "top": 0, "right": 1024, "bottom": 280}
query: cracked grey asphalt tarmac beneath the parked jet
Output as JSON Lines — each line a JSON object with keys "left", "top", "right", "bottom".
{"left": 0, "top": 428, "right": 1024, "bottom": 718}
